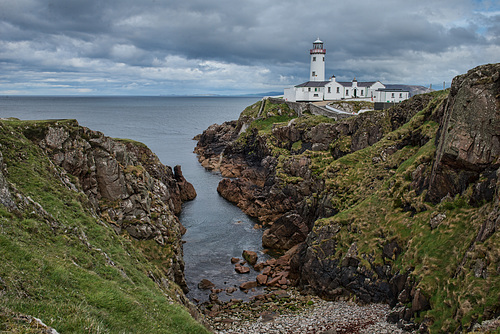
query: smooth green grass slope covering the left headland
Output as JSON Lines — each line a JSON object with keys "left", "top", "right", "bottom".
{"left": 0, "top": 121, "right": 207, "bottom": 333}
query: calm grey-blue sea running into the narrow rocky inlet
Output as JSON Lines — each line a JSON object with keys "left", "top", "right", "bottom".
{"left": 0, "top": 97, "right": 270, "bottom": 300}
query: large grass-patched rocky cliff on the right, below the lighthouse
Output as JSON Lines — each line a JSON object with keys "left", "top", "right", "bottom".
{"left": 196, "top": 64, "right": 500, "bottom": 332}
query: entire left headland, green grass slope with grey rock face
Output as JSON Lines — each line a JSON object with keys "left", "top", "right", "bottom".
{"left": 0, "top": 120, "right": 205, "bottom": 332}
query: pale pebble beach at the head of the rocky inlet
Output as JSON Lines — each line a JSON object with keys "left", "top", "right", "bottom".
{"left": 206, "top": 288, "right": 409, "bottom": 334}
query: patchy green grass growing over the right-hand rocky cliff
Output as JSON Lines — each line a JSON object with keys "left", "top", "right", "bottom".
{"left": 241, "top": 91, "right": 500, "bottom": 332}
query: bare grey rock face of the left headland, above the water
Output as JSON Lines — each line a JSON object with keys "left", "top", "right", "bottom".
{"left": 23, "top": 121, "right": 196, "bottom": 289}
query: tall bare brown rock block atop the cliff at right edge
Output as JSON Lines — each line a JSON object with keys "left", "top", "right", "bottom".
{"left": 428, "top": 64, "right": 500, "bottom": 204}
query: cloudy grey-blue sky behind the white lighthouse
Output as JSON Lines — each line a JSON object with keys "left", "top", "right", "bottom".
{"left": 0, "top": 0, "right": 500, "bottom": 96}
